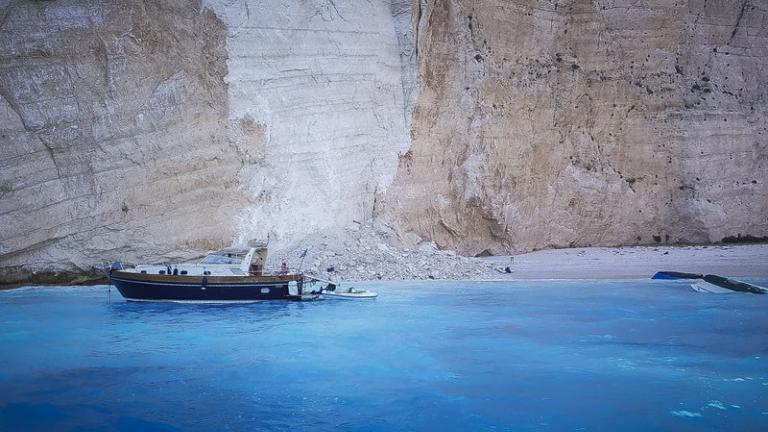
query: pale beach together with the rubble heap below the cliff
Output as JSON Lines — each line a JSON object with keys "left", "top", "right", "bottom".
{"left": 274, "top": 225, "right": 768, "bottom": 281}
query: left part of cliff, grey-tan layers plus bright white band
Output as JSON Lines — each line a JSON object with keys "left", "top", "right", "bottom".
{"left": 0, "top": 0, "right": 415, "bottom": 282}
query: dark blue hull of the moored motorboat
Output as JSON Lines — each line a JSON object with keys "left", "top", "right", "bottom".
{"left": 110, "top": 272, "right": 301, "bottom": 302}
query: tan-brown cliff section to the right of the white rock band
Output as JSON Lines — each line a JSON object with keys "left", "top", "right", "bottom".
{"left": 382, "top": 0, "right": 768, "bottom": 254}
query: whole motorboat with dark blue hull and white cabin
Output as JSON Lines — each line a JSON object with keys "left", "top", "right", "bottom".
{"left": 108, "top": 243, "right": 322, "bottom": 303}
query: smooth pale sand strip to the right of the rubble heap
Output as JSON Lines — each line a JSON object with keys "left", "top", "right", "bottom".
{"left": 482, "top": 244, "right": 768, "bottom": 279}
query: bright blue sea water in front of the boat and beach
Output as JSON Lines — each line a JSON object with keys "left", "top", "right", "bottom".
{"left": 0, "top": 281, "right": 768, "bottom": 431}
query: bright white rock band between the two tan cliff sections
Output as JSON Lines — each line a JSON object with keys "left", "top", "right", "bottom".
{"left": 205, "top": 0, "right": 415, "bottom": 246}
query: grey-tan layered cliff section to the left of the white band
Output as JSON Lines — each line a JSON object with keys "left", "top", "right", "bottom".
{"left": 0, "top": 0, "right": 247, "bottom": 283}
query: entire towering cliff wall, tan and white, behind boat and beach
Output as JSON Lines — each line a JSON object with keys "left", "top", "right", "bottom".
{"left": 0, "top": 0, "right": 768, "bottom": 282}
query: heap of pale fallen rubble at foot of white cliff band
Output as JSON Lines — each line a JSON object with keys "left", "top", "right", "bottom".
{"left": 267, "top": 222, "right": 511, "bottom": 280}
